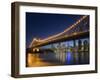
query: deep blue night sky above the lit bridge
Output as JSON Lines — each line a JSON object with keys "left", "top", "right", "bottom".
{"left": 26, "top": 12, "right": 83, "bottom": 47}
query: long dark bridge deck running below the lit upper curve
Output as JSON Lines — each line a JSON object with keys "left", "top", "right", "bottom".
{"left": 32, "top": 31, "right": 89, "bottom": 48}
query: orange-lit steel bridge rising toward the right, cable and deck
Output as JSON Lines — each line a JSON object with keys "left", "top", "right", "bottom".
{"left": 29, "top": 15, "right": 89, "bottom": 49}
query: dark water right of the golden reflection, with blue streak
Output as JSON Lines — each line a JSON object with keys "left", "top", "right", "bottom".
{"left": 27, "top": 51, "right": 89, "bottom": 66}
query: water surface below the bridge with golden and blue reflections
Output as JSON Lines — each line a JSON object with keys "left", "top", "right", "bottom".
{"left": 27, "top": 51, "right": 89, "bottom": 67}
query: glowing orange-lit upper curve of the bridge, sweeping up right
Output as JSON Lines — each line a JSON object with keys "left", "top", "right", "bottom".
{"left": 31, "top": 15, "right": 87, "bottom": 47}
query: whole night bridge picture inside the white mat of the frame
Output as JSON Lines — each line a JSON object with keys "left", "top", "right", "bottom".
{"left": 26, "top": 13, "right": 89, "bottom": 67}
